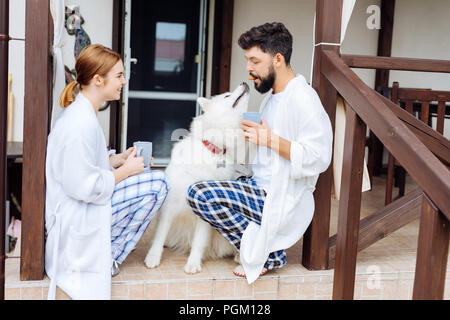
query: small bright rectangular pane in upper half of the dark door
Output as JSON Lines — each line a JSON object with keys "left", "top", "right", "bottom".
{"left": 155, "top": 22, "right": 186, "bottom": 74}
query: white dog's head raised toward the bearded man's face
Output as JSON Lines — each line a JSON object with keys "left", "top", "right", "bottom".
{"left": 197, "top": 82, "right": 250, "bottom": 129}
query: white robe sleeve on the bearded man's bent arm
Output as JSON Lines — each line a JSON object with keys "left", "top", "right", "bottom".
{"left": 290, "top": 106, "right": 333, "bottom": 179}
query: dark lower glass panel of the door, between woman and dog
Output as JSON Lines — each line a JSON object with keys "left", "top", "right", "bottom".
{"left": 127, "top": 99, "right": 196, "bottom": 159}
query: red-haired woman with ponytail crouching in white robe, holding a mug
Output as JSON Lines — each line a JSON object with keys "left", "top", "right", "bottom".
{"left": 45, "top": 45, "right": 168, "bottom": 299}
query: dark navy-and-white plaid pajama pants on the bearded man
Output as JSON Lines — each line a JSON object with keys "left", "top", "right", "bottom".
{"left": 187, "top": 177, "right": 287, "bottom": 270}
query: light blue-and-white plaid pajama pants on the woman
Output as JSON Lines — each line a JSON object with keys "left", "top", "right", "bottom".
{"left": 111, "top": 169, "right": 169, "bottom": 264}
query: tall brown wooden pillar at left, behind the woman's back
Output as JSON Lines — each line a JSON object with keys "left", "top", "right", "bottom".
{"left": 20, "top": 0, "right": 53, "bottom": 280}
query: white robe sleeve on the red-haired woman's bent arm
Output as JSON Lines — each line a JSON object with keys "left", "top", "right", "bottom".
{"left": 62, "top": 133, "right": 115, "bottom": 205}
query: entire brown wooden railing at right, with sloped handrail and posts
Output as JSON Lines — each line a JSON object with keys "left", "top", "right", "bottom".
{"left": 321, "top": 50, "right": 450, "bottom": 299}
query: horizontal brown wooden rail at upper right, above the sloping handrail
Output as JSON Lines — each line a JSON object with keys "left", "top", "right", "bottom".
{"left": 342, "top": 54, "right": 450, "bottom": 73}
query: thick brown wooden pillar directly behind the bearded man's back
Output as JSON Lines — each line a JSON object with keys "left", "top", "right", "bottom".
{"left": 302, "top": 0, "right": 342, "bottom": 270}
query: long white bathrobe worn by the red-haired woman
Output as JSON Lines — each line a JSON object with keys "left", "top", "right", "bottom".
{"left": 45, "top": 94, "right": 115, "bottom": 299}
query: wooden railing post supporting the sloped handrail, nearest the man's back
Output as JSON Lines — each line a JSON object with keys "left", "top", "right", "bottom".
{"left": 333, "top": 105, "right": 366, "bottom": 299}
